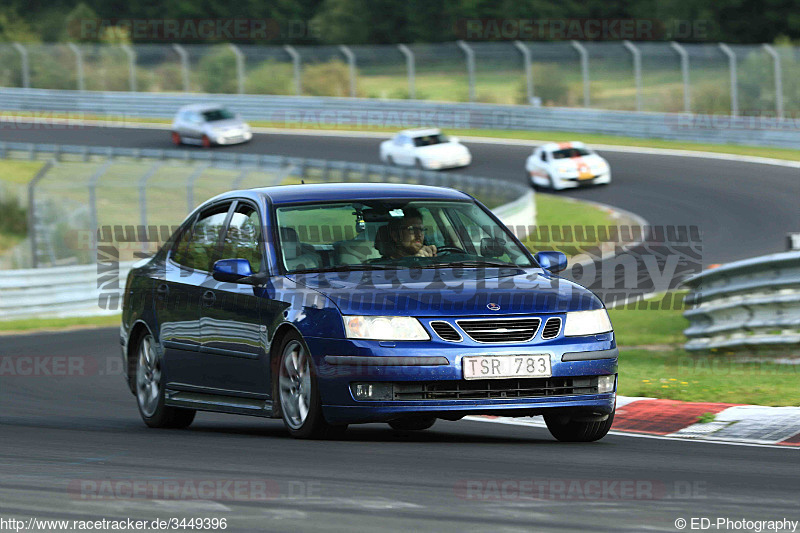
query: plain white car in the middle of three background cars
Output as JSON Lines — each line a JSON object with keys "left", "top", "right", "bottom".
{"left": 381, "top": 128, "right": 472, "bottom": 170}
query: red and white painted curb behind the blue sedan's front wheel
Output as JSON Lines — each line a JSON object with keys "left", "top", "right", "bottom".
{"left": 468, "top": 396, "right": 800, "bottom": 448}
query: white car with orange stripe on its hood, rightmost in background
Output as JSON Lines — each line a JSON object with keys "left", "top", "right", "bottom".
{"left": 525, "top": 142, "right": 611, "bottom": 191}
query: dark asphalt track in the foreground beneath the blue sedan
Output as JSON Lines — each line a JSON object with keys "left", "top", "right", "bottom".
{"left": 0, "top": 329, "right": 800, "bottom": 532}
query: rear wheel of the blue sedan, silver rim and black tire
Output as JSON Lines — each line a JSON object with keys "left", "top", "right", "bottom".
{"left": 136, "top": 333, "right": 197, "bottom": 428}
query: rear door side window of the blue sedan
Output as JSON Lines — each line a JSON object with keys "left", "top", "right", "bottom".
{"left": 172, "top": 204, "right": 230, "bottom": 272}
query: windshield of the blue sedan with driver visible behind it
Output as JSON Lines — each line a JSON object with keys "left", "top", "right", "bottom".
{"left": 276, "top": 200, "right": 534, "bottom": 273}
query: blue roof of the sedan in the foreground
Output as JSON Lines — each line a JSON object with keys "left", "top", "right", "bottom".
{"left": 209, "top": 183, "right": 472, "bottom": 205}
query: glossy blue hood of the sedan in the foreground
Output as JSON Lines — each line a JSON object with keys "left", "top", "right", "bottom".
{"left": 287, "top": 268, "right": 603, "bottom": 317}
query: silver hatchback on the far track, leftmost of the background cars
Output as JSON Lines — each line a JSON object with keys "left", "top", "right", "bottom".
{"left": 171, "top": 104, "right": 253, "bottom": 148}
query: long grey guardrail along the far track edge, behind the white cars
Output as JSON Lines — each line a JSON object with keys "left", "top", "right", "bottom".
{"left": 0, "top": 88, "right": 800, "bottom": 148}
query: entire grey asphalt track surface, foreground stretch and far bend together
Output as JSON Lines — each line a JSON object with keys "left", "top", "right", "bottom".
{"left": 0, "top": 123, "right": 800, "bottom": 532}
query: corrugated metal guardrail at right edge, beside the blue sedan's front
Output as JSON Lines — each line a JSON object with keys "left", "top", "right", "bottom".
{"left": 684, "top": 252, "right": 800, "bottom": 350}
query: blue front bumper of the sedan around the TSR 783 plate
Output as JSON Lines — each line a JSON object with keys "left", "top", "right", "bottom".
{"left": 306, "top": 335, "right": 617, "bottom": 423}
